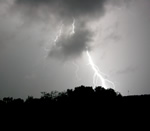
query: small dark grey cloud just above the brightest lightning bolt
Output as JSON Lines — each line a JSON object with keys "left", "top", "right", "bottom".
{"left": 49, "top": 22, "right": 93, "bottom": 60}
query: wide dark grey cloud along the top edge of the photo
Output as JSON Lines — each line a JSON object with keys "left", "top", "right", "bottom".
{"left": 16, "top": 0, "right": 107, "bottom": 17}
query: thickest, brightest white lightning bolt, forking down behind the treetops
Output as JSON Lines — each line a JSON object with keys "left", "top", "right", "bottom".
{"left": 86, "top": 50, "right": 115, "bottom": 89}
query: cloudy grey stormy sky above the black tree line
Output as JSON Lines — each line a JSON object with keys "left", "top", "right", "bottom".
{"left": 0, "top": 0, "right": 150, "bottom": 98}
